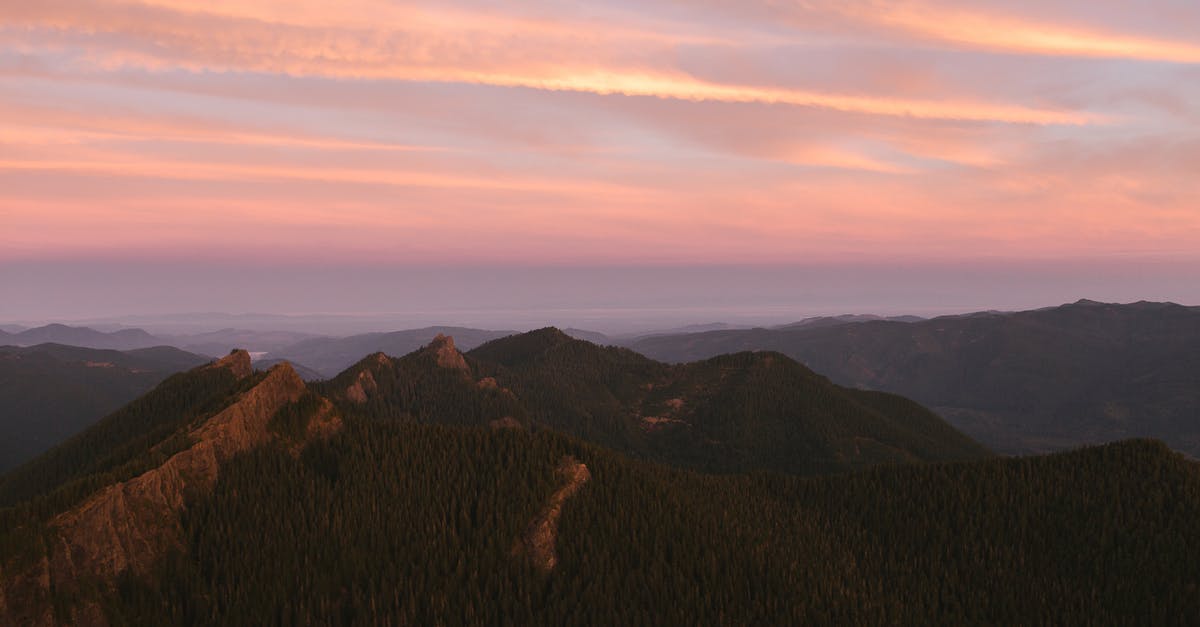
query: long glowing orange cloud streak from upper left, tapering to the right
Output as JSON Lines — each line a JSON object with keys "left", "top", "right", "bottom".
{"left": 10, "top": 0, "right": 1104, "bottom": 125}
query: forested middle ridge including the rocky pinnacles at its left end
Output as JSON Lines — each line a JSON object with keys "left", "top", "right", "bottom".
{"left": 322, "top": 328, "right": 988, "bottom": 473}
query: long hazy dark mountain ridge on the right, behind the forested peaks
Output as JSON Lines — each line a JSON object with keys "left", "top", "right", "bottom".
{"left": 632, "top": 300, "right": 1200, "bottom": 456}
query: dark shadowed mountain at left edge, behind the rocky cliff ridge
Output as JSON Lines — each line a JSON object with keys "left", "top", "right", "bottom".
{"left": 0, "top": 344, "right": 206, "bottom": 472}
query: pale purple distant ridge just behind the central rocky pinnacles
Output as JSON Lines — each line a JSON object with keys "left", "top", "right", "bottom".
{"left": 266, "top": 327, "right": 512, "bottom": 377}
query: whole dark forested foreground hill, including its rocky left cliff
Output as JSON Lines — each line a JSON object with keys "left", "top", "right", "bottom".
{"left": 0, "top": 341, "right": 1200, "bottom": 625}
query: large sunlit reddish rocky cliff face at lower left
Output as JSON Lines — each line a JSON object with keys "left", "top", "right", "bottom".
{"left": 0, "top": 351, "right": 328, "bottom": 625}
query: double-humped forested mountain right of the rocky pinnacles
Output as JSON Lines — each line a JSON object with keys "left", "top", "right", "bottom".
{"left": 467, "top": 328, "right": 986, "bottom": 473}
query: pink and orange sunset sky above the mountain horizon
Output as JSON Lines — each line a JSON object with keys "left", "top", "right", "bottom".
{"left": 0, "top": 0, "right": 1200, "bottom": 321}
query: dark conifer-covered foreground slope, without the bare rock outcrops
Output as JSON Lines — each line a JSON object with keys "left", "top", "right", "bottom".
{"left": 11, "top": 420, "right": 1200, "bottom": 625}
